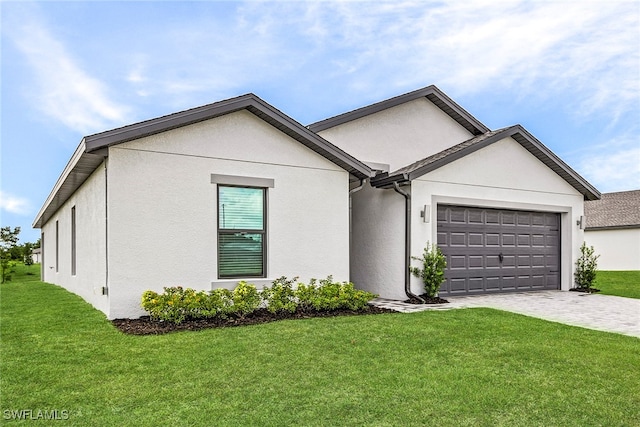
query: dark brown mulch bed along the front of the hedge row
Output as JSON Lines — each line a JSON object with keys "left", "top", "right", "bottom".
{"left": 111, "top": 305, "right": 395, "bottom": 335}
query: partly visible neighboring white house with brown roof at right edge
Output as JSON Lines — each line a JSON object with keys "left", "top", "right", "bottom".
{"left": 584, "top": 190, "right": 640, "bottom": 270}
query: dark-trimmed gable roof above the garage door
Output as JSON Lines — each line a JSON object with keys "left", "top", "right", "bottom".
{"left": 371, "top": 125, "right": 600, "bottom": 200}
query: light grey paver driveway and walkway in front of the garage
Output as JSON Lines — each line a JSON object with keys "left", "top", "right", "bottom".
{"left": 372, "top": 291, "right": 640, "bottom": 338}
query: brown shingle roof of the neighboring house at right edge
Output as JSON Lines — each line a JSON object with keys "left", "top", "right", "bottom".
{"left": 584, "top": 190, "right": 640, "bottom": 231}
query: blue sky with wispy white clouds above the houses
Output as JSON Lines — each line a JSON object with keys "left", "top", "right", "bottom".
{"left": 0, "top": 0, "right": 640, "bottom": 242}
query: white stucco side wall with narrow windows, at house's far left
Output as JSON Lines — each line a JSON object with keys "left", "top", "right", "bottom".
{"left": 41, "top": 164, "right": 108, "bottom": 314}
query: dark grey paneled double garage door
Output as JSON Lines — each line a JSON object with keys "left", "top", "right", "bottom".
{"left": 438, "top": 205, "right": 560, "bottom": 296}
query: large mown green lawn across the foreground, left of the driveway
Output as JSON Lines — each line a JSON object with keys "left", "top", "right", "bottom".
{"left": 0, "top": 266, "right": 640, "bottom": 426}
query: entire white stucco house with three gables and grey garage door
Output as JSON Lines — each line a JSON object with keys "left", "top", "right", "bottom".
{"left": 34, "top": 86, "right": 600, "bottom": 319}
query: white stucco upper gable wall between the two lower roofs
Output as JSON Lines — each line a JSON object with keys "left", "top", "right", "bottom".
{"left": 319, "top": 98, "right": 472, "bottom": 171}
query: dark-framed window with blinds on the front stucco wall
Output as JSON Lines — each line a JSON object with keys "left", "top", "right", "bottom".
{"left": 218, "top": 185, "right": 266, "bottom": 278}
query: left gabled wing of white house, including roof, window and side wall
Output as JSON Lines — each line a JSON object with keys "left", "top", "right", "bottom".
{"left": 34, "top": 94, "right": 371, "bottom": 319}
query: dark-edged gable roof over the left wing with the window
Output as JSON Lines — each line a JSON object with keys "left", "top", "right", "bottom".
{"left": 33, "top": 93, "right": 373, "bottom": 228}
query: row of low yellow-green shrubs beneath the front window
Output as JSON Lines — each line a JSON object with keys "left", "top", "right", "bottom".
{"left": 142, "top": 276, "right": 377, "bottom": 323}
